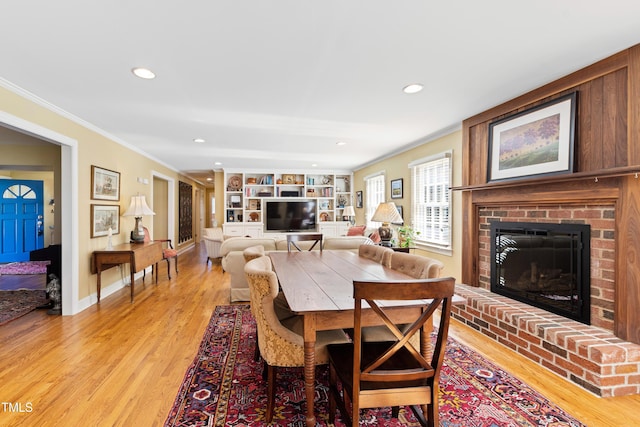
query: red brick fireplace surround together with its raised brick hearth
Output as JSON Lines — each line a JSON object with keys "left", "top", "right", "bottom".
{"left": 453, "top": 204, "right": 640, "bottom": 397}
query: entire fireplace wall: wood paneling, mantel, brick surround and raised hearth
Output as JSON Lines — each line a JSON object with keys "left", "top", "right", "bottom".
{"left": 454, "top": 44, "right": 640, "bottom": 396}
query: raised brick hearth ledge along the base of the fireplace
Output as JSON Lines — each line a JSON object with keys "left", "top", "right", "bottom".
{"left": 452, "top": 285, "right": 640, "bottom": 397}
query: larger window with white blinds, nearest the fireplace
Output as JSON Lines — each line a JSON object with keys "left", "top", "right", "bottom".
{"left": 409, "top": 152, "right": 451, "bottom": 249}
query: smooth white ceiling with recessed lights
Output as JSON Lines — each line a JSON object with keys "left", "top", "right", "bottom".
{"left": 0, "top": 0, "right": 640, "bottom": 185}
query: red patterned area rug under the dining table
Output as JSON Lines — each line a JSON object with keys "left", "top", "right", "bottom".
{"left": 165, "top": 305, "right": 583, "bottom": 427}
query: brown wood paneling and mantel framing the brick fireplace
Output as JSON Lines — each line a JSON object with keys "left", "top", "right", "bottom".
{"left": 459, "top": 45, "right": 640, "bottom": 343}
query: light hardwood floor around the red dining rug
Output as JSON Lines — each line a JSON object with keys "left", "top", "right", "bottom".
{"left": 0, "top": 242, "right": 640, "bottom": 427}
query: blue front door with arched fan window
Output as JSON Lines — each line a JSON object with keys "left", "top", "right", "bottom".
{"left": 0, "top": 179, "right": 44, "bottom": 262}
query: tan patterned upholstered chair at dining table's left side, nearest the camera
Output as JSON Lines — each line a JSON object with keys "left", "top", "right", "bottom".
{"left": 244, "top": 256, "right": 349, "bottom": 423}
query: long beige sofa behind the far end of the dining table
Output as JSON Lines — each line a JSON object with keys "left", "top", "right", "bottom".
{"left": 220, "top": 236, "right": 374, "bottom": 302}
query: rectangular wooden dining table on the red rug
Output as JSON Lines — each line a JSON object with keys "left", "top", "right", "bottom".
{"left": 269, "top": 250, "right": 462, "bottom": 426}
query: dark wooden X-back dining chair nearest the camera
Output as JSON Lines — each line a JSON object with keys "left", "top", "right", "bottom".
{"left": 327, "top": 277, "right": 455, "bottom": 427}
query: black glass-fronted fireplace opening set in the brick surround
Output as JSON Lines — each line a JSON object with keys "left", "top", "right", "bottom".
{"left": 491, "top": 222, "right": 591, "bottom": 324}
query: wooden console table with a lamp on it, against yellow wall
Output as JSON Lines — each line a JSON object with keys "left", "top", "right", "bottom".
{"left": 91, "top": 242, "right": 162, "bottom": 302}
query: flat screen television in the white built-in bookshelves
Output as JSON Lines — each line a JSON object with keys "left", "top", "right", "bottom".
{"left": 265, "top": 199, "right": 317, "bottom": 231}
